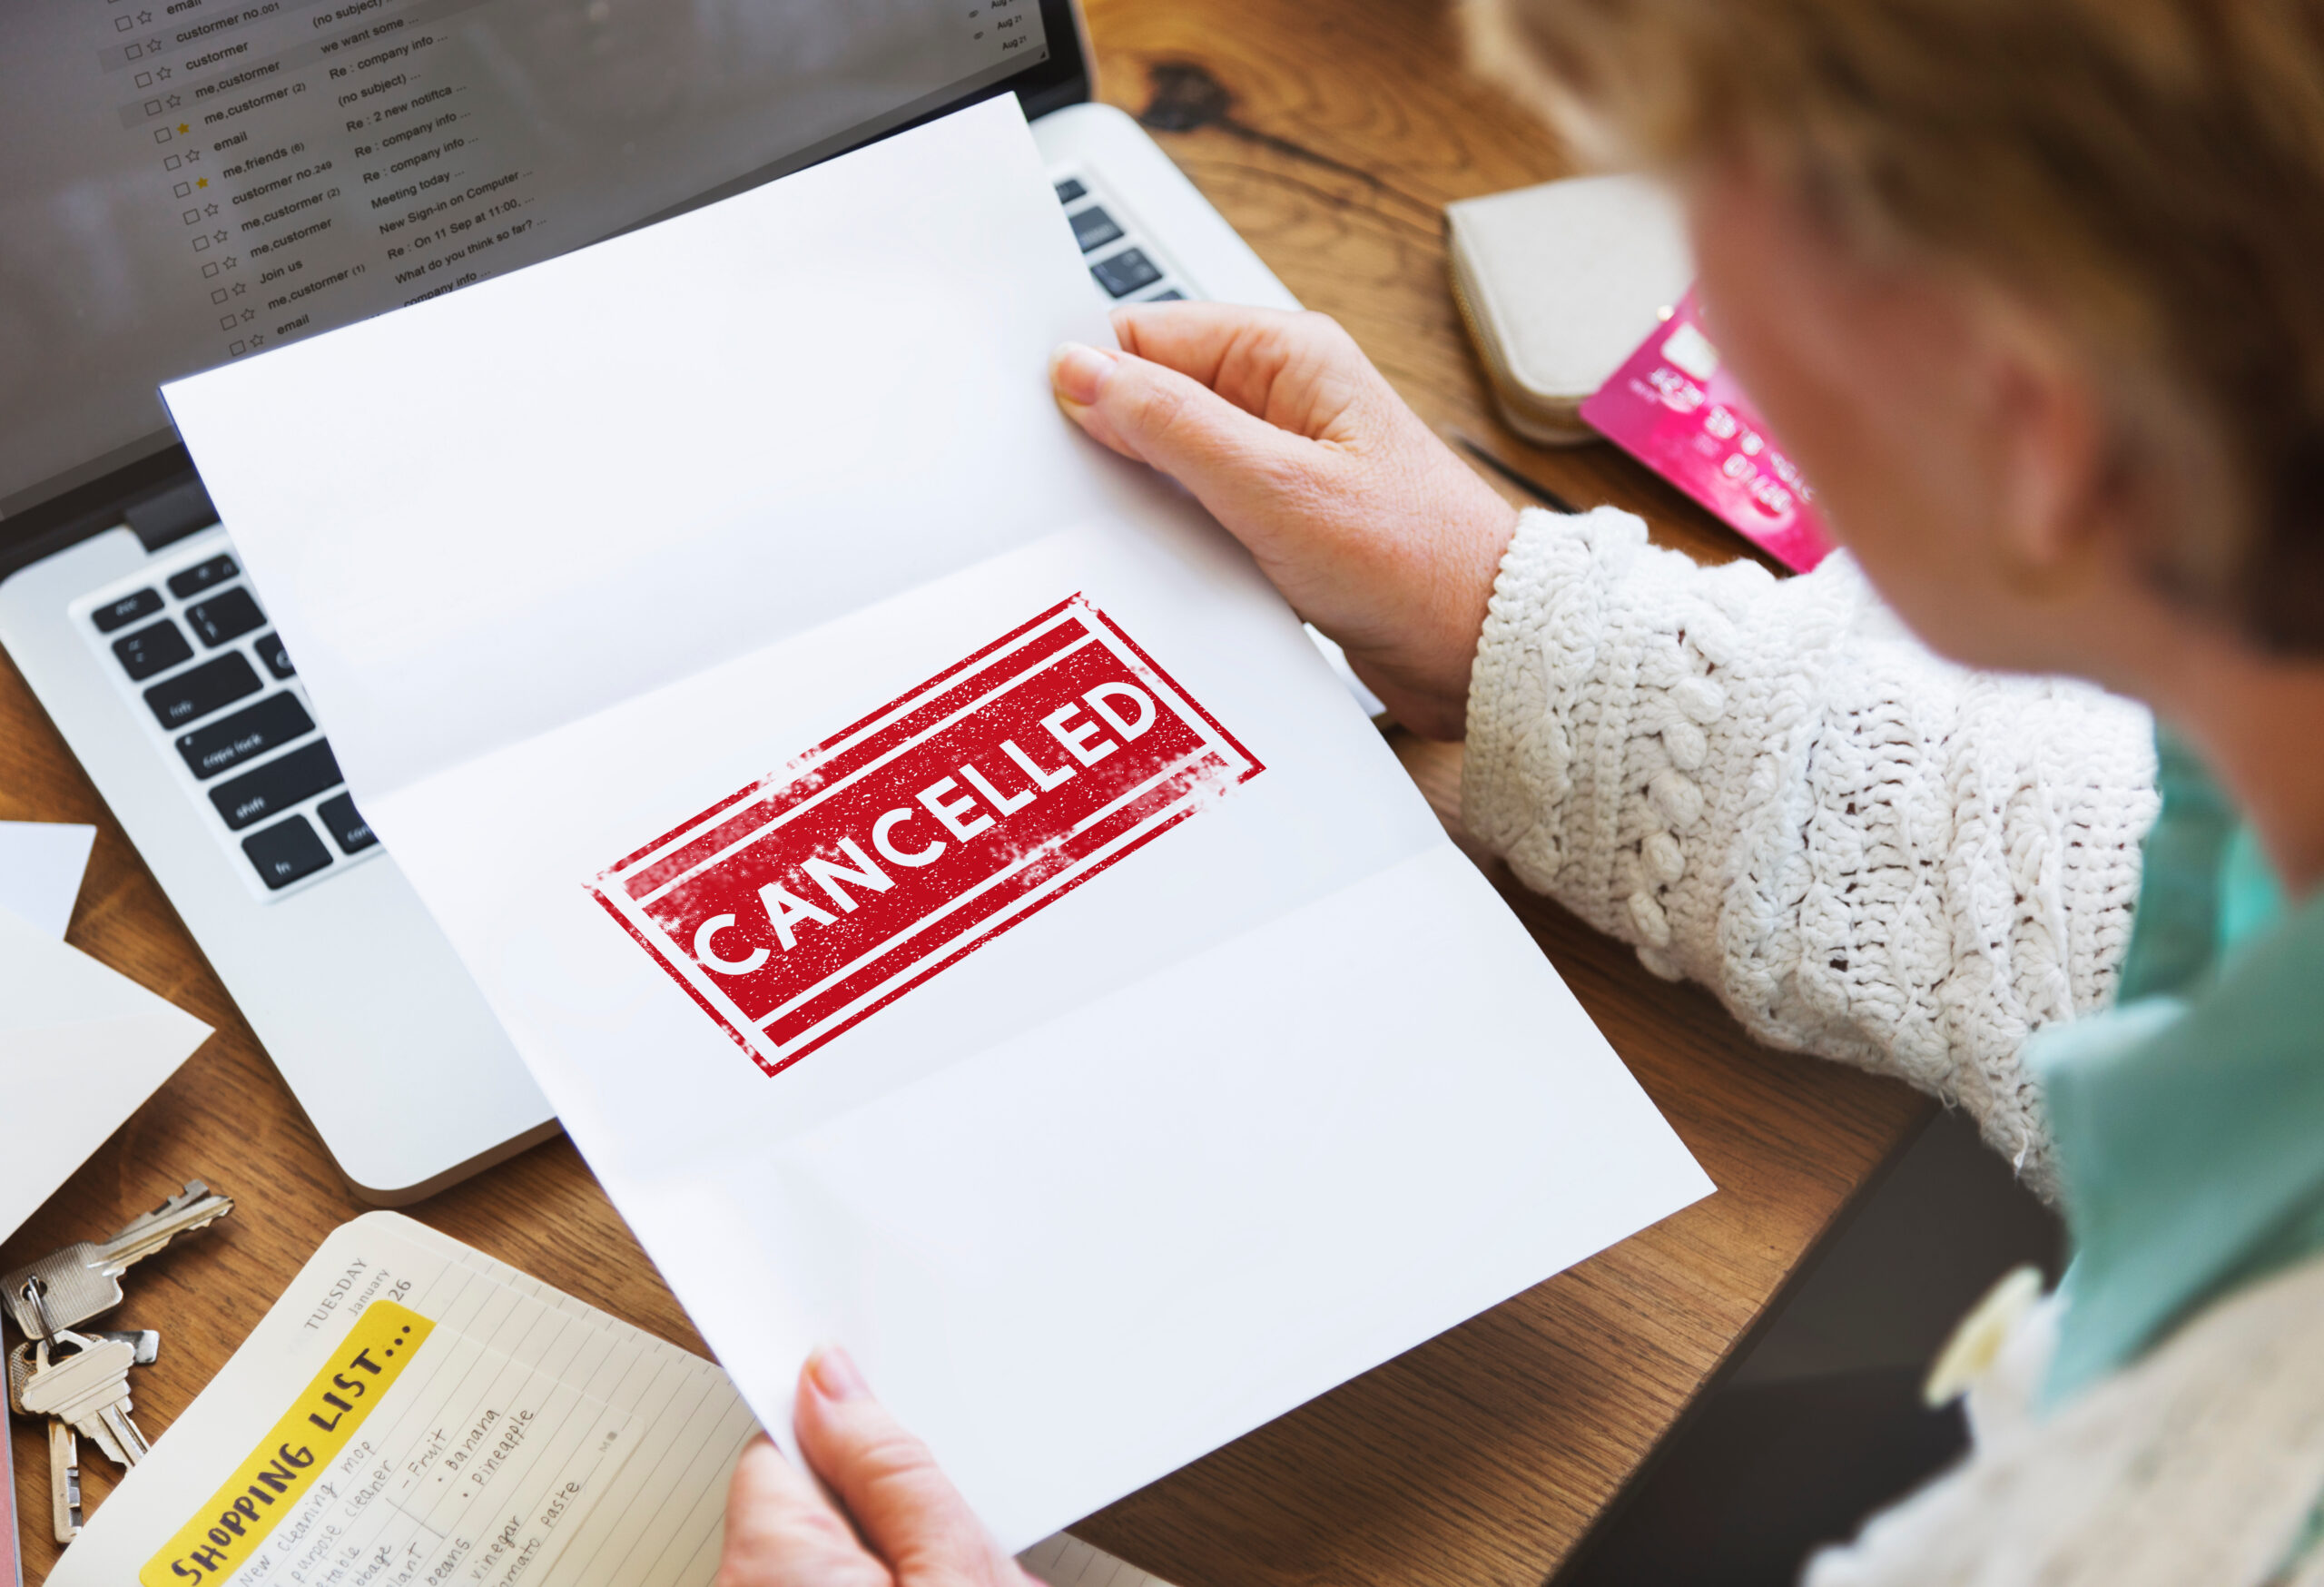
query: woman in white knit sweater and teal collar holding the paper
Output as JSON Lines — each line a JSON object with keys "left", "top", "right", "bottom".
{"left": 723, "top": 0, "right": 2324, "bottom": 1587}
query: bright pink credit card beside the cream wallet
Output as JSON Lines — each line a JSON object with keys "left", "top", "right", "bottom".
{"left": 1582, "top": 286, "right": 1831, "bottom": 572}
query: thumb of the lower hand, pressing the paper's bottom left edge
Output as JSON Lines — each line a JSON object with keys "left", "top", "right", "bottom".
{"left": 793, "top": 1347, "right": 1025, "bottom": 1587}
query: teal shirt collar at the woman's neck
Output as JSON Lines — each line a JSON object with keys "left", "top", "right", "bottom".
{"left": 2026, "top": 734, "right": 2324, "bottom": 1405}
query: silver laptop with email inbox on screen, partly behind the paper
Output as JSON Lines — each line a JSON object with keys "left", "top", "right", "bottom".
{"left": 0, "top": 0, "right": 1296, "bottom": 1206}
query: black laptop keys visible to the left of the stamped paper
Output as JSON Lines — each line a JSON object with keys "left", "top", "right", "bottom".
{"left": 74, "top": 530, "right": 379, "bottom": 897}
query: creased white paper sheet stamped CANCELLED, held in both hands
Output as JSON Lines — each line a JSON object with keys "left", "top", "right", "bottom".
{"left": 165, "top": 100, "right": 1710, "bottom": 1547}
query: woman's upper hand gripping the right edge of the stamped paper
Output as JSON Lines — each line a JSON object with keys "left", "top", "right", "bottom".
{"left": 1050, "top": 302, "right": 1518, "bottom": 739}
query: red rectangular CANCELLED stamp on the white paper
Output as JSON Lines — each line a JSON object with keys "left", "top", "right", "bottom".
{"left": 593, "top": 595, "right": 1265, "bottom": 1073}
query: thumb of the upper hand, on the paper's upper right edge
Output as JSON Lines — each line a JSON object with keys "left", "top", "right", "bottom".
{"left": 1049, "top": 341, "right": 1296, "bottom": 497}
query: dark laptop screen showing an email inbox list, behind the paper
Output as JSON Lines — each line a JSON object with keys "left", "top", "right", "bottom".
{"left": 0, "top": 0, "right": 1080, "bottom": 514}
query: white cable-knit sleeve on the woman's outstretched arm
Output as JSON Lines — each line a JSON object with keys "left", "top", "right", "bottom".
{"left": 1462, "top": 508, "right": 2157, "bottom": 1194}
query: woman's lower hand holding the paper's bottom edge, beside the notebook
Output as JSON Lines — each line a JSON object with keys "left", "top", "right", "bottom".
{"left": 718, "top": 1350, "right": 1039, "bottom": 1587}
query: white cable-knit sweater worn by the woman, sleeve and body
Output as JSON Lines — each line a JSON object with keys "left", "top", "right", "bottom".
{"left": 1462, "top": 508, "right": 2324, "bottom": 1587}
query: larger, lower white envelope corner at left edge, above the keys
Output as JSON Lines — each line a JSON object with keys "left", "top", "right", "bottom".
{"left": 0, "top": 911, "right": 209, "bottom": 1238}
